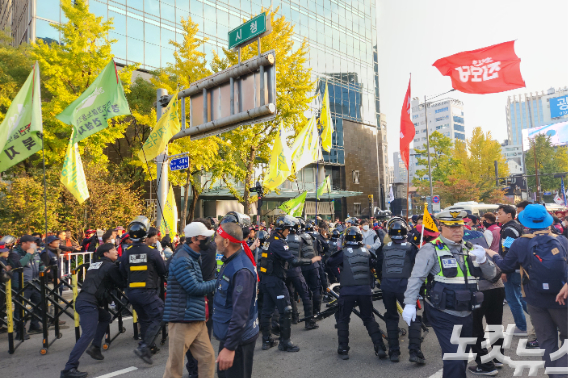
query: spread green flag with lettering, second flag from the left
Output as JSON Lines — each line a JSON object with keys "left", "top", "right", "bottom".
{"left": 55, "top": 60, "right": 130, "bottom": 144}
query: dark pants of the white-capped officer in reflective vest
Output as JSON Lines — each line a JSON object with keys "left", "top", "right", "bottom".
{"left": 426, "top": 303, "right": 472, "bottom": 378}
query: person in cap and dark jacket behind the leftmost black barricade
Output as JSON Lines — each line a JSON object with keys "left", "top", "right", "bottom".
{"left": 14, "top": 235, "right": 45, "bottom": 340}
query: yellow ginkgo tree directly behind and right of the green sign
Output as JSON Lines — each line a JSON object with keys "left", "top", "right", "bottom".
{"left": 216, "top": 9, "right": 314, "bottom": 213}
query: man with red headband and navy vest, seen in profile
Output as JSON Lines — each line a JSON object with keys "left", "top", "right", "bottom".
{"left": 213, "top": 223, "right": 259, "bottom": 378}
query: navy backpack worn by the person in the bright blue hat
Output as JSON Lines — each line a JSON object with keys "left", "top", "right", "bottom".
{"left": 521, "top": 233, "right": 568, "bottom": 295}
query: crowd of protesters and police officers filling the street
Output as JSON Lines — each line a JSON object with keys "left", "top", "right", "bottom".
{"left": 0, "top": 202, "right": 568, "bottom": 378}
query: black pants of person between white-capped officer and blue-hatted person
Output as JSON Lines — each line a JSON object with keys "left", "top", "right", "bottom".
{"left": 471, "top": 287, "right": 505, "bottom": 369}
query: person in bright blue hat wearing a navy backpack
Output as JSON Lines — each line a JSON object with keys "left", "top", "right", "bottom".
{"left": 487, "top": 205, "right": 568, "bottom": 377}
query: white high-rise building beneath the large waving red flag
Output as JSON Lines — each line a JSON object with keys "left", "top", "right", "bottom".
{"left": 411, "top": 97, "right": 465, "bottom": 149}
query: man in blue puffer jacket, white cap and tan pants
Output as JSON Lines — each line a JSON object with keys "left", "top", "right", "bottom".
{"left": 163, "top": 222, "right": 220, "bottom": 378}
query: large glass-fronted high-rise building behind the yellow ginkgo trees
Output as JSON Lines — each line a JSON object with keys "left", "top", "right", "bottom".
{"left": 0, "top": 0, "right": 388, "bottom": 214}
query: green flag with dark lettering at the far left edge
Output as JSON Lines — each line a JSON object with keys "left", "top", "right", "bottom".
{"left": 0, "top": 62, "right": 43, "bottom": 172}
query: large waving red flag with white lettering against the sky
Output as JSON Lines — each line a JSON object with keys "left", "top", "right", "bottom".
{"left": 433, "top": 41, "right": 525, "bottom": 94}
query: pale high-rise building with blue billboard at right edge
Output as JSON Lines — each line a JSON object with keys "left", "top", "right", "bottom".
{"left": 505, "top": 87, "right": 568, "bottom": 145}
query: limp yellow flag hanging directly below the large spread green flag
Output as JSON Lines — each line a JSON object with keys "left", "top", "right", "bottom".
{"left": 60, "top": 130, "right": 89, "bottom": 204}
